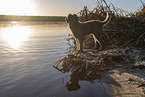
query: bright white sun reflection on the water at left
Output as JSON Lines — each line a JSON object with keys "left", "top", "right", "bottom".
{"left": 0, "top": 26, "right": 32, "bottom": 51}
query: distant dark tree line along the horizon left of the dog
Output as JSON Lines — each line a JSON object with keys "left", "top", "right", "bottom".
{"left": 0, "top": 15, "right": 65, "bottom": 21}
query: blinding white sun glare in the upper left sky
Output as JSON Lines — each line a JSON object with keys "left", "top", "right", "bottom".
{"left": 0, "top": 0, "right": 37, "bottom": 15}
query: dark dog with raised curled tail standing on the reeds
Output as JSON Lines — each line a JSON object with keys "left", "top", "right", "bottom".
{"left": 66, "top": 13, "right": 110, "bottom": 52}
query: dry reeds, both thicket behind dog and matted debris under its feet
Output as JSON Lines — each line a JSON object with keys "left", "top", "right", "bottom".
{"left": 53, "top": 0, "right": 145, "bottom": 77}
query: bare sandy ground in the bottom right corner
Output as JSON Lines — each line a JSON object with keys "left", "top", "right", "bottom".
{"left": 101, "top": 68, "right": 145, "bottom": 97}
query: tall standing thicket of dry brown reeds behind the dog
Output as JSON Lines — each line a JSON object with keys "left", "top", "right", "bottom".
{"left": 79, "top": 0, "right": 145, "bottom": 49}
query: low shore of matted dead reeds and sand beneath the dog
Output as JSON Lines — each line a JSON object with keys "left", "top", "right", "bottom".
{"left": 53, "top": 49, "right": 145, "bottom": 97}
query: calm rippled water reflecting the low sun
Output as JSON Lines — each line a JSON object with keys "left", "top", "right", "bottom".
{"left": 0, "top": 22, "right": 108, "bottom": 97}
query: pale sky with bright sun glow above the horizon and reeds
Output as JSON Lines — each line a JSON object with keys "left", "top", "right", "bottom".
{"left": 0, "top": 0, "right": 145, "bottom": 16}
